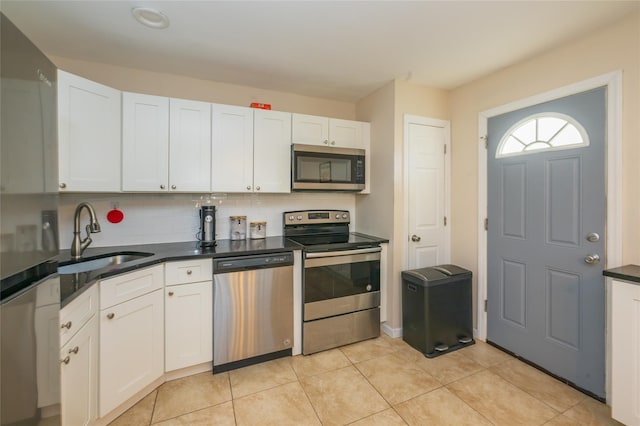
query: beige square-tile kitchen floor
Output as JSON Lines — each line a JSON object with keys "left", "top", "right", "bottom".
{"left": 111, "top": 335, "right": 620, "bottom": 426}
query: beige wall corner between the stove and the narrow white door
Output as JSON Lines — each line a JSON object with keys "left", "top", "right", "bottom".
{"left": 356, "top": 81, "right": 449, "bottom": 329}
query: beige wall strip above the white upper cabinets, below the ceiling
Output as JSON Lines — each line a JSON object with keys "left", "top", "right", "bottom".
{"left": 50, "top": 56, "right": 355, "bottom": 120}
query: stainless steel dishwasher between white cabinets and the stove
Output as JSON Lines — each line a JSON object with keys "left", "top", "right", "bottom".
{"left": 213, "top": 252, "right": 293, "bottom": 373}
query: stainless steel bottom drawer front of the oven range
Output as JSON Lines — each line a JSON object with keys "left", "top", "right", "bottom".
{"left": 302, "top": 308, "right": 380, "bottom": 355}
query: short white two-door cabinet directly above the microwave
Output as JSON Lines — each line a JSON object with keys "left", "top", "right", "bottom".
{"left": 292, "top": 114, "right": 365, "bottom": 149}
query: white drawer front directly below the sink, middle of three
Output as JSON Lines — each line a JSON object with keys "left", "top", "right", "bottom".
{"left": 100, "top": 265, "right": 164, "bottom": 309}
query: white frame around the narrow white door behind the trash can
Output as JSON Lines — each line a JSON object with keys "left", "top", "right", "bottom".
{"left": 402, "top": 114, "right": 451, "bottom": 269}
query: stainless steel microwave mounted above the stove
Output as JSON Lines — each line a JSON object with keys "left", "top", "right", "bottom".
{"left": 291, "top": 144, "right": 365, "bottom": 191}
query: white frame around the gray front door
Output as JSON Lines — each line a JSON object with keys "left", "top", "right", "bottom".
{"left": 474, "top": 70, "right": 622, "bottom": 400}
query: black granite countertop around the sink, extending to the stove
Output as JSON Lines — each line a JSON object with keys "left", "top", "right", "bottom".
{"left": 58, "top": 237, "right": 303, "bottom": 307}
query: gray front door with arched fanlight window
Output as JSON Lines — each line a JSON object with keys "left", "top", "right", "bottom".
{"left": 487, "top": 87, "right": 606, "bottom": 397}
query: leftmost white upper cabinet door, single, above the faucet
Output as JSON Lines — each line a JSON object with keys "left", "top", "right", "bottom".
{"left": 58, "top": 70, "right": 121, "bottom": 192}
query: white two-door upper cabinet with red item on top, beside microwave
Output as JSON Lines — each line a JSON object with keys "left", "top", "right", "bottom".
{"left": 211, "top": 105, "right": 291, "bottom": 193}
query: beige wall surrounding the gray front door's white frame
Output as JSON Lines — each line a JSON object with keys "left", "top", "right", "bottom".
{"left": 451, "top": 14, "right": 640, "bottom": 326}
